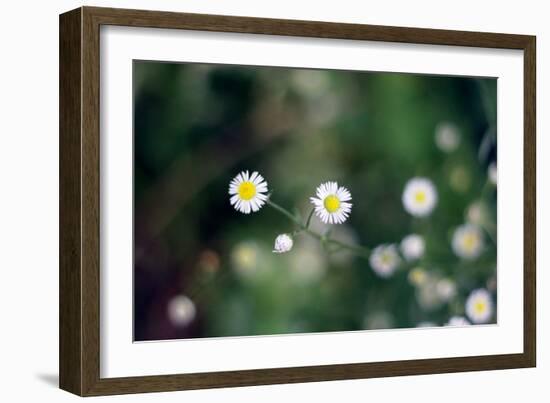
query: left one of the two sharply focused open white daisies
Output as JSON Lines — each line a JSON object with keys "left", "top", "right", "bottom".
{"left": 229, "top": 171, "right": 267, "bottom": 214}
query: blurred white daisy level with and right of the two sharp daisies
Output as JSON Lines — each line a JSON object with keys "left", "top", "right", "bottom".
{"left": 402, "top": 177, "right": 437, "bottom": 217}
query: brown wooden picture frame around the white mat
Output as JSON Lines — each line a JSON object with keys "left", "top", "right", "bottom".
{"left": 59, "top": 7, "right": 536, "bottom": 396}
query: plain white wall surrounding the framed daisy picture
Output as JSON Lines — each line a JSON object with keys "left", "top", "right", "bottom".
{"left": 0, "top": 0, "right": 550, "bottom": 403}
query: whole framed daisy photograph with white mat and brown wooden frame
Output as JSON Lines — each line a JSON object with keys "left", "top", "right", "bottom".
{"left": 60, "top": 7, "right": 536, "bottom": 396}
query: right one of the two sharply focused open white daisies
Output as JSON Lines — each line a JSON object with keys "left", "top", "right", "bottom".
{"left": 309, "top": 182, "right": 352, "bottom": 224}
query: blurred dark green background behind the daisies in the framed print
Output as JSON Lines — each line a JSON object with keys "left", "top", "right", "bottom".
{"left": 133, "top": 61, "right": 497, "bottom": 340}
